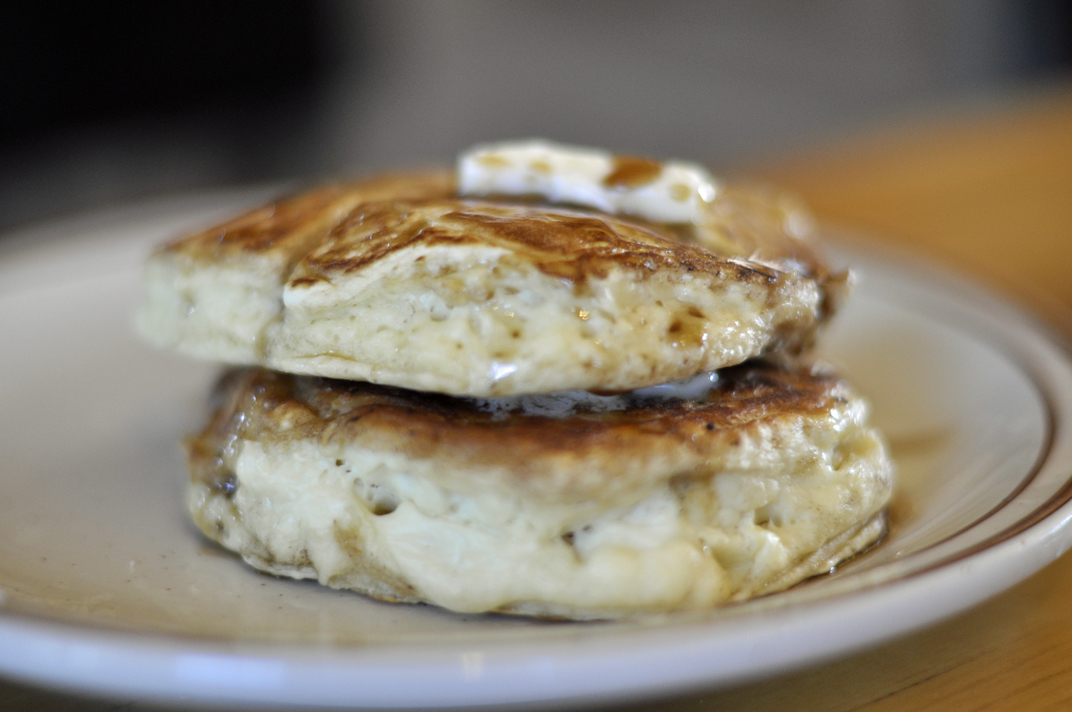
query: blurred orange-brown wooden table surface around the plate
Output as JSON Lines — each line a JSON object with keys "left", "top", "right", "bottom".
{"left": 0, "top": 85, "right": 1072, "bottom": 712}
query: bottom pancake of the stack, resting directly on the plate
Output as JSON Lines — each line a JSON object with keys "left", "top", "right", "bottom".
{"left": 188, "top": 365, "right": 892, "bottom": 619}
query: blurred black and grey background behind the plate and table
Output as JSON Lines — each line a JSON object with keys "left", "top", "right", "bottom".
{"left": 0, "top": 0, "right": 1072, "bottom": 229}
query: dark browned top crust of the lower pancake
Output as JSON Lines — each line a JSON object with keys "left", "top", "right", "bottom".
{"left": 188, "top": 362, "right": 848, "bottom": 492}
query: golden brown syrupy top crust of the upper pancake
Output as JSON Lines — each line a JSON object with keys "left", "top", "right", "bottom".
{"left": 159, "top": 169, "right": 830, "bottom": 281}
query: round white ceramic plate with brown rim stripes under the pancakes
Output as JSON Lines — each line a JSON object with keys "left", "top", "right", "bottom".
{"left": 0, "top": 194, "right": 1072, "bottom": 707}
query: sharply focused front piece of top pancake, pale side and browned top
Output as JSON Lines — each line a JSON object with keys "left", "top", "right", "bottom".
{"left": 265, "top": 202, "right": 823, "bottom": 396}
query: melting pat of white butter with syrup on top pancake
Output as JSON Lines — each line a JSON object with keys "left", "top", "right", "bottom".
{"left": 458, "top": 139, "right": 717, "bottom": 224}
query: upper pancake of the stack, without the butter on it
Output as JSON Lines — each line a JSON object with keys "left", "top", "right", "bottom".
{"left": 139, "top": 173, "right": 845, "bottom": 396}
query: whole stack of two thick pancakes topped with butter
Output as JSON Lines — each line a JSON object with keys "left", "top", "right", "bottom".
{"left": 138, "top": 142, "right": 892, "bottom": 619}
